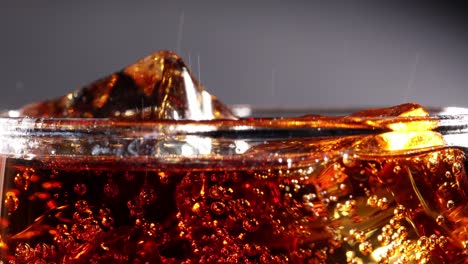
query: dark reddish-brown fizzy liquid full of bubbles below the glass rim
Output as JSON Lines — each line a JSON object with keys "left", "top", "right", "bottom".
{"left": 0, "top": 145, "right": 468, "bottom": 263}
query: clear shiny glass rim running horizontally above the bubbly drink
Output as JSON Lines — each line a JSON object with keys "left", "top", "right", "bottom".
{"left": 0, "top": 106, "right": 468, "bottom": 163}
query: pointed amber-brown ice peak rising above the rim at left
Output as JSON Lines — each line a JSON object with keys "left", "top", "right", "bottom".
{"left": 19, "top": 51, "right": 236, "bottom": 120}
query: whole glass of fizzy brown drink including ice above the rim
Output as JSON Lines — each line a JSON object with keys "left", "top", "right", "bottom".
{"left": 0, "top": 52, "right": 468, "bottom": 264}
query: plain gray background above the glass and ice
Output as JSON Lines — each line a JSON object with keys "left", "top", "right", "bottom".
{"left": 0, "top": 0, "right": 468, "bottom": 111}
